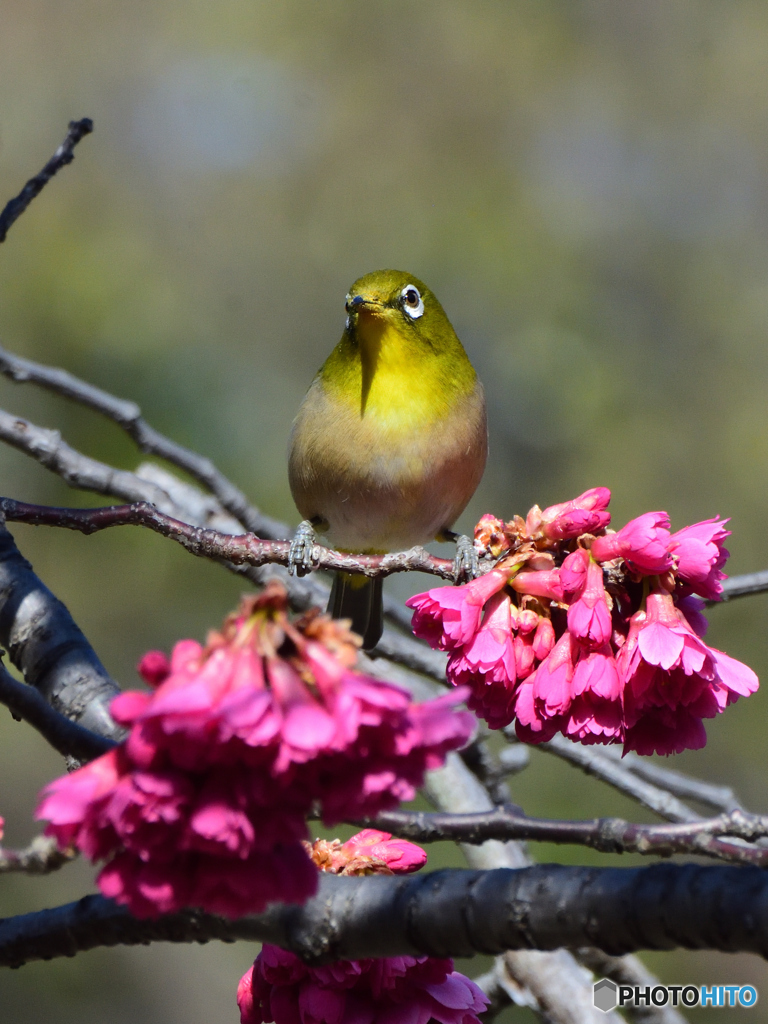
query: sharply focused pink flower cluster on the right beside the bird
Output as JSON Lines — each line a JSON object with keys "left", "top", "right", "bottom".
{"left": 408, "top": 487, "right": 758, "bottom": 754}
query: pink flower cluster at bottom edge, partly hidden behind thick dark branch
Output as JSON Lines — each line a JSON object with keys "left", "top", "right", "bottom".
{"left": 238, "top": 829, "right": 488, "bottom": 1024}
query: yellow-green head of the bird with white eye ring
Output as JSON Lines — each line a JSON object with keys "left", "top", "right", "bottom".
{"left": 346, "top": 270, "right": 456, "bottom": 352}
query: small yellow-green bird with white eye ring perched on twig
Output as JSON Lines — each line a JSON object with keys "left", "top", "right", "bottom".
{"left": 289, "top": 270, "right": 487, "bottom": 650}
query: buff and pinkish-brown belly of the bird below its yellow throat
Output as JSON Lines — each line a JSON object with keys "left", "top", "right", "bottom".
{"left": 290, "top": 382, "right": 486, "bottom": 552}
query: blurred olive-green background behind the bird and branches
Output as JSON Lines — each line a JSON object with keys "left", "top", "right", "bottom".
{"left": 0, "top": 0, "right": 768, "bottom": 1024}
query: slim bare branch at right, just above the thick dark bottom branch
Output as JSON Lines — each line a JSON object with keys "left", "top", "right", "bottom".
{"left": 364, "top": 805, "right": 768, "bottom": 867}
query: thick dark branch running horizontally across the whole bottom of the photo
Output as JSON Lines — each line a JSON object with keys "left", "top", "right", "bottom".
{"left": 0, "top": 864, "right": 768, "bottom": 967}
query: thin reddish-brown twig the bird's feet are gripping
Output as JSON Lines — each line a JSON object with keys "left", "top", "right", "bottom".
{"left": 0, "top": 498, "right": 454, "bottom": 580}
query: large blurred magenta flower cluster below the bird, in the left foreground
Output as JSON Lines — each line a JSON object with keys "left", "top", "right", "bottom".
{"left": 37, "top": 585, "right": 474, "bottom": 918}
